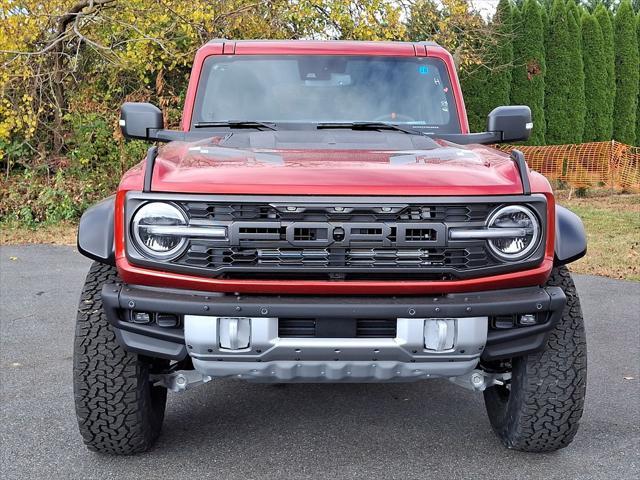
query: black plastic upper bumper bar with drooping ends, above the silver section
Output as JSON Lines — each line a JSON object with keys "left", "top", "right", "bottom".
{"left": 102, "top": 284, "right": 566, "bottom": 360}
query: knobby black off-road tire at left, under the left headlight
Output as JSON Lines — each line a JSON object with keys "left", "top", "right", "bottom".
{"left": 73, "top": 263, "right": 167, "bottom": 455}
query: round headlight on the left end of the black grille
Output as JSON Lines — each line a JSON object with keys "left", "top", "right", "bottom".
{"left": 131, "top": 202, "right": 187, "bottom": 259}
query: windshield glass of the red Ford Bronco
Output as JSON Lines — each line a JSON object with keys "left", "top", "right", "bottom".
{"left": 192, "top": 55, "right": 460, "bottom": 133}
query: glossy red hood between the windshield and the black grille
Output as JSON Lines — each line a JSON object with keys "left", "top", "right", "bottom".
{"left": 121, "top": 136, "right": 522, "bottom": 196}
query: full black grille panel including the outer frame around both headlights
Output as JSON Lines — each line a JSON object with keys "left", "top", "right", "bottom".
{"left": 122, "top": 195, "right": 546, "bottom": 281}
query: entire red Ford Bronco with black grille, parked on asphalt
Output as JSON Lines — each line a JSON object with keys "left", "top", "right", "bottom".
{"left": 73, "top": 40, "right": 586, "bottom": 454}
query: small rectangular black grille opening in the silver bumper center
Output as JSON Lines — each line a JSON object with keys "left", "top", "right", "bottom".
{"left": 278, "top": 318, "right": 397, "bottom": 338}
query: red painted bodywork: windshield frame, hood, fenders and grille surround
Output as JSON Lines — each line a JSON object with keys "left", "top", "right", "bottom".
{"left": 115, "top": 41, "right": 555, "bottom": 295}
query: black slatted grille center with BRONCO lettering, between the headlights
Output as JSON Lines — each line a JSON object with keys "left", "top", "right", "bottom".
{"left": 169, "top": 202, "right": 499, "bottom": 280}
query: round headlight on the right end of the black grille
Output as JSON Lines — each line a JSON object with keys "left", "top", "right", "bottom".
{"left": 487, "top": 205, "right": 540, "bottom": 260}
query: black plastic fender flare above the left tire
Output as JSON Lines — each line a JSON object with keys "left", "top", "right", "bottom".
{"left": 78, "top": 195, "right": 116, "bottom": 266}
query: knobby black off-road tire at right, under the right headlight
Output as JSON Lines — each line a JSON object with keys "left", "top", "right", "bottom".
{"left": 484, "top": 267, "right": 587, "bottom": 452}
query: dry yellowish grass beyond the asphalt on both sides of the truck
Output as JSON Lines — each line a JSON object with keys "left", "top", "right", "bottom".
{"left": 0, "top": 192, "right": 640, "bottom": 281}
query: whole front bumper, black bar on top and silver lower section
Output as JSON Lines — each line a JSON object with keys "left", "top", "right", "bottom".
{"left": 102, "top": 284, "right": 566, "bottom": 382}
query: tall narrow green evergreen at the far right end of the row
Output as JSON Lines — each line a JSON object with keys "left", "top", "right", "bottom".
{"left": 613, "top": 0, "right": 640, "bottom": 144}
